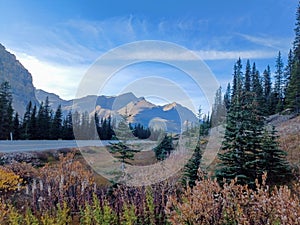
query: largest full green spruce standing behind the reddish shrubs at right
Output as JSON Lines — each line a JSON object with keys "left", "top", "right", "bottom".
{"left": 215, "top": 60, "right": 264, "bottom": 185}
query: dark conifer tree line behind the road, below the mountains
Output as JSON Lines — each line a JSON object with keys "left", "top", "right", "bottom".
{"left": 0, "top": 81, "right": 165, "bottom": 140}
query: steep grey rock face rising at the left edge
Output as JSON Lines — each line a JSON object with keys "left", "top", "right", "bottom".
{"left": 0, "top": 44, "right": 38, "bottom": 116}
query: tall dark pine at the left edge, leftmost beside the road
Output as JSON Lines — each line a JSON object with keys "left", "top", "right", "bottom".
{"left": 0, "top": 81, "right": 14, "bottom": 140}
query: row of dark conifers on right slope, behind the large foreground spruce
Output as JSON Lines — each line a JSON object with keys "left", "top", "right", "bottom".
{"left": 211, "top": 50, "right": 300, "bottom": 126}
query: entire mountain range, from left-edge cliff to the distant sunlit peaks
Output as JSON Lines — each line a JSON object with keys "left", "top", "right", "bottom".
{"left": 0, "top": 44, "right": 198, "bottom": 132}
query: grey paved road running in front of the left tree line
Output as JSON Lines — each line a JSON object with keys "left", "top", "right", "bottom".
{"left": 0, "top": 140, "right": 113, "bottom": 152}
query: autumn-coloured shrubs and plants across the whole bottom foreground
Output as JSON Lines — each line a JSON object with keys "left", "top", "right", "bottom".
{"left": 0, "top": 153, "right": 300, "bottom": 225}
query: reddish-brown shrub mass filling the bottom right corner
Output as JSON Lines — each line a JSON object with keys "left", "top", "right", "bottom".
{"left": 166, "top": 174, "right": 300, "bottom": 225}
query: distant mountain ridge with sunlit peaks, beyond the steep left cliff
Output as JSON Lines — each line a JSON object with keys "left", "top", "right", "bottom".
{"left": 36, "top": 90, "right": 198, "bottom": 132}
